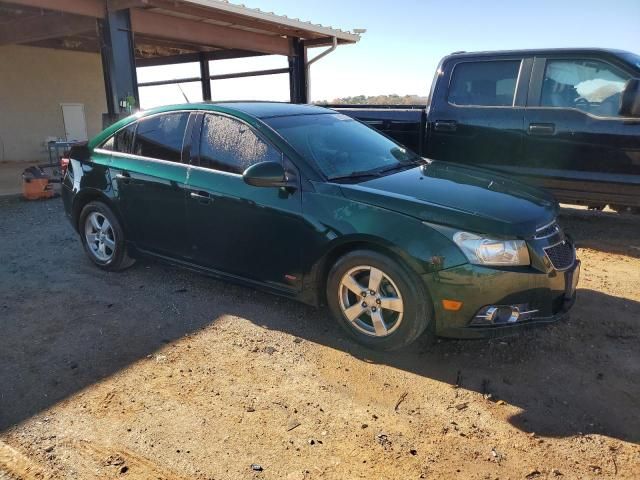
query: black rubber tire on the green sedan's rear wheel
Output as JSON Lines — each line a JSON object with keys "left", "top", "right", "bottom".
{"left": 78, "top": 201, "right": 135, "bottom": 271}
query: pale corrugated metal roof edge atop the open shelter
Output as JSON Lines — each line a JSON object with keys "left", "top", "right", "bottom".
{"left": 182, "top": 0, "right": 360, "bottom": 43}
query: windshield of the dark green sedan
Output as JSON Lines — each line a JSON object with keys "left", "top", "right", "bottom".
{"left": 265, "top": 113, "right": 421, "bottom": 180}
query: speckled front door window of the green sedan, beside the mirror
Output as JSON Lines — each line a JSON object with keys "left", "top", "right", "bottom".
{"left": 200, "top": 115, "right": 282, "bottom": 174}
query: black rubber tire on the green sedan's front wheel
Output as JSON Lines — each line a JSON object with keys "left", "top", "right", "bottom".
{"left": 326, "top": 250, "right": 433, "bottom": 350}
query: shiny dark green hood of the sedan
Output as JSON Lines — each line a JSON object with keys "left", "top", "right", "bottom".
{"left": 340, "top": 161, "right": 558, "bottom": 237}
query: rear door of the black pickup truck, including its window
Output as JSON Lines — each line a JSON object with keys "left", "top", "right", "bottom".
{"left": 427, "top": 57, "right": 532, "bottom": 170}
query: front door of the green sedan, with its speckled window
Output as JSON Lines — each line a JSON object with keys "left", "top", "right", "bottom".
{"left": 187, "top": 114, "right": 305, "bottom": 291}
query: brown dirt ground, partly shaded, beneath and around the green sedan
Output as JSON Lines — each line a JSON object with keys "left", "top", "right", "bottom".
{"left": 0, "top": 199, "right": 640, "bottom": 480}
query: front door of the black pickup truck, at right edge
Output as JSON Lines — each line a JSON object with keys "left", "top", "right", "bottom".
{"left": 525, "top": 56, "right": 640, "bottom": 206}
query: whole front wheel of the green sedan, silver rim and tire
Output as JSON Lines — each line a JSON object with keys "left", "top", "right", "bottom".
{"left": 327, "top": 250, "right": 433, "bottom": 350}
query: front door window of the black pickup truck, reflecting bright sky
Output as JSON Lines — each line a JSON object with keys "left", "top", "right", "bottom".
{"left": 540, "top": 60, "right": 630, "bottom": 117}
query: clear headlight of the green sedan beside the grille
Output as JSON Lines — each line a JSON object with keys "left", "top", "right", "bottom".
{"left": 453, "top": 232, "right": 531, "bottom": 266}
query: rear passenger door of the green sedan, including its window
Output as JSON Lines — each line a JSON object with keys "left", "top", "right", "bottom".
{"left": 111, "top": 111, "right": 190, "bottom": 258}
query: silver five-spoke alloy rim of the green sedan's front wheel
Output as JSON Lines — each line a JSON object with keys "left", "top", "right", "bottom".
{"left": 338, "top": 265, "right": 404, "bottom": 337}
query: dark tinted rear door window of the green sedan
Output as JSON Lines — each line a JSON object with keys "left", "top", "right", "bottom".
{"left": 133, "top": 112, "right": 189, "bottom": 162}
